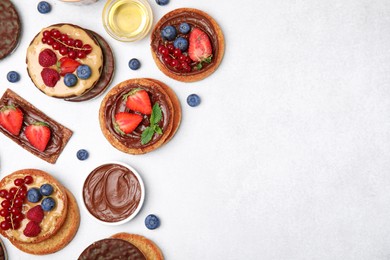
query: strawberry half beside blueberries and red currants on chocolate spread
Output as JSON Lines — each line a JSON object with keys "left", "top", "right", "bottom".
{"left": 188, "top": 28, "right": 213, "bottom": 62}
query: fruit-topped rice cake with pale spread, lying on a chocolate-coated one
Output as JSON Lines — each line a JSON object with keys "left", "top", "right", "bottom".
{"left": 26, "top": 24, "right": 104, "bottom": 98}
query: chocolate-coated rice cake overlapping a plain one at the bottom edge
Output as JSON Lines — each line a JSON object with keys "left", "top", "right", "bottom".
{"left": 78, "top": 238, "right": 146, "bottom": 260}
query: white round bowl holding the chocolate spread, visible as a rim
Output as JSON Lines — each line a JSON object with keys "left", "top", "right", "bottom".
{"left": 81, "top": 161, "right": 145, "bottom": 226}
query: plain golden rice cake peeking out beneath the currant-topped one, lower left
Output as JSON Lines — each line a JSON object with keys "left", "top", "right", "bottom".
{"left": 10, "top": 189, "right": 80, "bottom": 255}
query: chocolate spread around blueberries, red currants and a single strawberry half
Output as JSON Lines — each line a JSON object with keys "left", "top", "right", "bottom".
{"left": 151, "top": 10, "right": 219, "bottom": 75}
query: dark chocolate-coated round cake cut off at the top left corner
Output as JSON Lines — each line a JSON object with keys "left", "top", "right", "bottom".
{"left": 0, "top": 0, "right": 21, "bottom": 60}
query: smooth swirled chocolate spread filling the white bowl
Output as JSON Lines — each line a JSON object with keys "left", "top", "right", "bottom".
{"left": 83, "top": 164, "right": 142, "bottom": 222}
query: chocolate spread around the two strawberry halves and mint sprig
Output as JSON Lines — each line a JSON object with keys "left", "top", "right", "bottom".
{"left": 104, "top": 84, "right": 171, "bottom": 148}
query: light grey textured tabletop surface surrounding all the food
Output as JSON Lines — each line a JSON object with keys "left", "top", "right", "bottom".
{"left": 0, "top": 0, "right": 390, "bottom": 260}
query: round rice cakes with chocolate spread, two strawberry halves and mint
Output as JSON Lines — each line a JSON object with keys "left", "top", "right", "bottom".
{"left": 99, "top": 78, "right": 181, "bottom": 154}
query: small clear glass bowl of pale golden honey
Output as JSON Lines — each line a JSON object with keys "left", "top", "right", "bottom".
{"left": 103, "top": 0, "right": 153, "bottom": 42}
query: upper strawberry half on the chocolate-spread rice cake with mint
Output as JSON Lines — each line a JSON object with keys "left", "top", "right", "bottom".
{"left": 123, "top": 88, "right": 152, "bottom": 115}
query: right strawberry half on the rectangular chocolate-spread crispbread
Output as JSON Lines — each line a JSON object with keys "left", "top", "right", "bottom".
{"left": 24, "top": 122, "right": 51, "bottom": 152}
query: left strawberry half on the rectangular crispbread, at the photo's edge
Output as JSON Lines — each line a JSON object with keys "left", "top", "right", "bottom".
{"left": 0, "top": 105, "right": 23, "bottom": 135}
